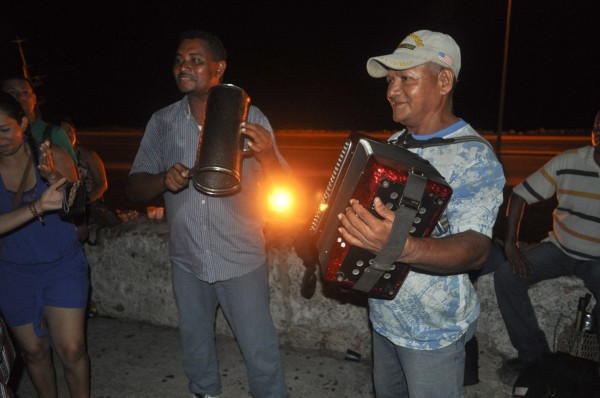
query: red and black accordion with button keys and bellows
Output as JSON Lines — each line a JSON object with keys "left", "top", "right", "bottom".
{"left": 310, "top": 132, "right": 452, "bottom": 299}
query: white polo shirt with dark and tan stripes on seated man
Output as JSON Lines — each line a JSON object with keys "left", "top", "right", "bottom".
{"left": 513, "top": 146, "right": 600, "bottom": 260}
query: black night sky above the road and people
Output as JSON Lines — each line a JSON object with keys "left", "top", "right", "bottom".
{"left": 0, "top": 0, "right": 600, "bottom": 131}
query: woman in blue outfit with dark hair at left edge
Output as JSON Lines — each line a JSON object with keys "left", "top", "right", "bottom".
{"left": 0, "top": 93, "right": 90, "bottom": 398}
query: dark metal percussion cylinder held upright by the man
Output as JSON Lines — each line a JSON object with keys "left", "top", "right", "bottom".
{"left": 192, "top": 84, "right": 250, "bottom": 196}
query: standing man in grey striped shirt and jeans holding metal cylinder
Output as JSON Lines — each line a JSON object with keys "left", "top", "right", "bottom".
{"left": 128, "top": 31, "right": 288, "bottom": 398}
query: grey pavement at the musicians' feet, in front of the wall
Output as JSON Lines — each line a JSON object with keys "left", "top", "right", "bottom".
{"left": 10, "top": 317, "right": 516, "bottom": 398}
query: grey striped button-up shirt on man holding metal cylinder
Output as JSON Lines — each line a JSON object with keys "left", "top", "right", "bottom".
{"left": 130, "top": 96, "right": 287, "bottom": 283}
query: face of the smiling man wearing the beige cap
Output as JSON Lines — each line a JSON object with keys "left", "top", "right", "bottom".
{"left": 387, "top": 65, "right": 442, "bottom": 133}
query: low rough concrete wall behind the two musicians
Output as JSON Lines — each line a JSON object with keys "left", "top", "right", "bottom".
{"left": 85, "top": 217, "right": 587, "bottom": 356}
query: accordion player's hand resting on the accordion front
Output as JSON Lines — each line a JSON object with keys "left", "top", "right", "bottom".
{"left": 338, "top": 198, "right": 395, "bottom": 254}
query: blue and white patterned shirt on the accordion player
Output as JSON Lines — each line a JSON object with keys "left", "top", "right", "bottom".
{"left": 369, "top": 120, "right": 505, "bottom": 350}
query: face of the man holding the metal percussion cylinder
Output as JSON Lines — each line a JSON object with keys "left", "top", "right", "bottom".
{"left": 173, "top": 39, "right": 226, "bottom": 96}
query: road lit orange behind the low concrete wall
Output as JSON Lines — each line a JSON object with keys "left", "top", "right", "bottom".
{"left": 78, "top": 130, "right": 590, "bottom": 229}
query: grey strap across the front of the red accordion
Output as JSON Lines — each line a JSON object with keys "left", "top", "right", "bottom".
{"left": 354, "top": 173, "right": 427, "bottom": 292}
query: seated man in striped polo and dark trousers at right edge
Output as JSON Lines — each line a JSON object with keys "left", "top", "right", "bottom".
{"left": 494, "top": 112, "right": 600, "bottom": 371}
